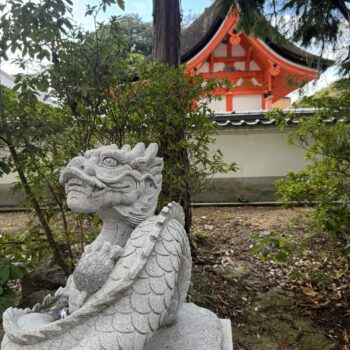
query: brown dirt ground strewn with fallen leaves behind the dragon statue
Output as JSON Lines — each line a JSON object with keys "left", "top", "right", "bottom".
{"left": 0, "top": 207, "right": 350, "bottom": 350}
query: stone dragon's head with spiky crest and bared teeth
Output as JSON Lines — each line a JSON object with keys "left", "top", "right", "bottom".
{"left": 60, "top": 143, "right": 163, "bottom": 225}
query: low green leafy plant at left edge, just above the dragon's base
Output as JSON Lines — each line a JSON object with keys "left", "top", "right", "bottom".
{"left": 0, "top": 256, "right": 24, "bottom": 321}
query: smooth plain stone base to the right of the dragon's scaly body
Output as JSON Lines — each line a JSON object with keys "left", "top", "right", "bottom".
{"left": 144, "top": 304, "right": 233, "bottom": 350}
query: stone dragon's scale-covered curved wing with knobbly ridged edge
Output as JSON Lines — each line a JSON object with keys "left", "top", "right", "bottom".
{"left": 2, "top": 203, "right": 191, "bottom": 350}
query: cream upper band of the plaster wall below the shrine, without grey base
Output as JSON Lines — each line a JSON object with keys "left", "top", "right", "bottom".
{"left": 210, "top": 126, "right": 307, "bottom": 178}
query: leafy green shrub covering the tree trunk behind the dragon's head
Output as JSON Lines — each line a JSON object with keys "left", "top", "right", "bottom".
{"left": 129, "top": 63, "right": 236, "bottom": 232}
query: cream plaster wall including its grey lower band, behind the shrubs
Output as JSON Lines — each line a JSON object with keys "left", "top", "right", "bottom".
{"left": 0, "top": 126, "right": 307, "bottom": 207}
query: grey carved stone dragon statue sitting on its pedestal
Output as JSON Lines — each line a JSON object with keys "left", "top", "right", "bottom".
{"left": 1, "top": 143, "right": 232, "bottom": 350}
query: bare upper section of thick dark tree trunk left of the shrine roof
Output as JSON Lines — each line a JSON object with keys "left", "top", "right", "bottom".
{"left": 153, "top": 0, "right": 181, "bottom": 67}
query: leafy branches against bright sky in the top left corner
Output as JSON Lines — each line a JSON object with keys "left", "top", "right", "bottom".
{"left": 0, "top": 0, "right": 125, "bottom": 60}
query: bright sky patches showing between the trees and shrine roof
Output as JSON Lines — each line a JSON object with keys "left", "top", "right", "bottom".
{"left": 1, "top": 0, "right": 338, "bottom": 102}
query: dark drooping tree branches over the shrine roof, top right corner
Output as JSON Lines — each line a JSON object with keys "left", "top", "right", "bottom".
{"left": 221, "top": 0, "right": 350, "bottom": 75}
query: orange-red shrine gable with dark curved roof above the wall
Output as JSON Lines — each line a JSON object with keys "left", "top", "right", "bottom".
{"left": 181, "top": 1, "right": 333, "bottom": 112}
